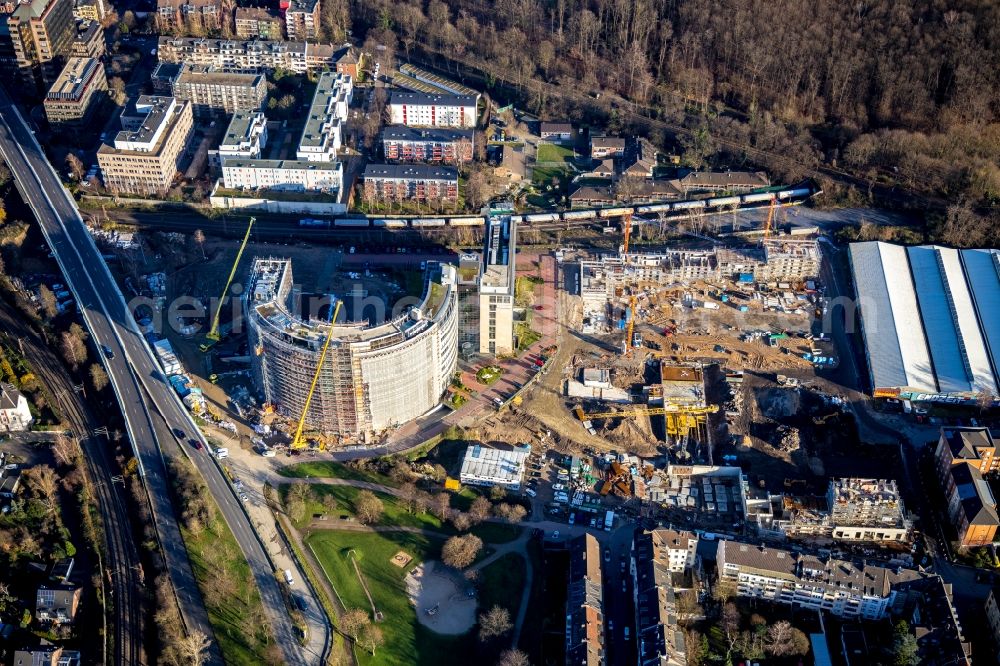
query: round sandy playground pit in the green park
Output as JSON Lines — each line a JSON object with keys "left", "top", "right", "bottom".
{"left": 406, "top": 560, "right": 477, "bottom": 635}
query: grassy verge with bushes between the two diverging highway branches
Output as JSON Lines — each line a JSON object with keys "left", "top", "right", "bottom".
{"left": 181, "top": 498, "right": 270, "bottom": 664}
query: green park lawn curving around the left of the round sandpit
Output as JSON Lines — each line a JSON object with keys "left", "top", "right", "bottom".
{"left": 306, "top": 530, "right": 475, "bottom": 666}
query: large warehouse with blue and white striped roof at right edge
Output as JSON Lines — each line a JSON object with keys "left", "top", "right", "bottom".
{"left": 850, "top": 242, "right": 1000, "bottom": 402}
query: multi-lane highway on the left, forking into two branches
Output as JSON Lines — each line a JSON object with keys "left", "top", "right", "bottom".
{"left": 0, "top": 90, "right": 327, "bottom": 664}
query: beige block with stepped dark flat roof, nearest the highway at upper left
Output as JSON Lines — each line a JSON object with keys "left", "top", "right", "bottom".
{"left": 97, "top": 95, "right": 194, "bottom": 196}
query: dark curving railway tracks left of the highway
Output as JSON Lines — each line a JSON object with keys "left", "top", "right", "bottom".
{"left": 0, "top": 304, "right": 147, "bottom": 664}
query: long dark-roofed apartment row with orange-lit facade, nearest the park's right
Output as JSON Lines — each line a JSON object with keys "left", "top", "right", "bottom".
{"left": 566, "top": 534, "right": 607, "bottom": 666}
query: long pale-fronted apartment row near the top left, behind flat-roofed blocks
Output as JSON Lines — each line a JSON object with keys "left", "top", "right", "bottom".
{"left": 157, "top": 36, "right": 340, "bottom": 74}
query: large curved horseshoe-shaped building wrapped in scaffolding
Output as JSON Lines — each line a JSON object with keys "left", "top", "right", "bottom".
{"left": 244, "top": 258, "right": 458, "bottom": 439}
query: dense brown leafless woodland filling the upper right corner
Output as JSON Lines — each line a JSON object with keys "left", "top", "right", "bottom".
{"left": 346, "top": 0, "right": 1000, "bottom": 244}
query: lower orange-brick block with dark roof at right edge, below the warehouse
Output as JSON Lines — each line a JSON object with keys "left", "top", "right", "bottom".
{"left": 939, "top": 462, "right": 1000, "bottom": 548}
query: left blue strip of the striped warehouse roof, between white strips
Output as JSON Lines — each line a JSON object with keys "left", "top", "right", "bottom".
{"left": 906, "top": 246, "right": 971, "bottom": 392}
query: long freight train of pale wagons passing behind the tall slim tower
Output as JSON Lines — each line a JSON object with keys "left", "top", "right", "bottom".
{"left": 299, "top": 187, "right": 817, "bottom": 229}
